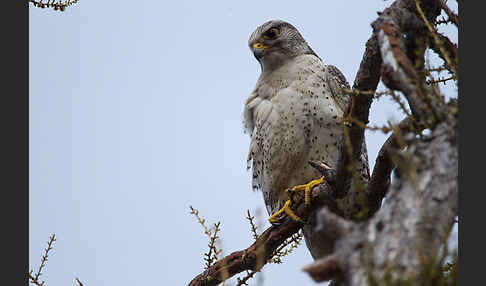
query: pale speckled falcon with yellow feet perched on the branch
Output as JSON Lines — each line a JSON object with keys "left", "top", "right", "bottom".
{"left": 243, "top": 20, "right": 369, "bottom": 259}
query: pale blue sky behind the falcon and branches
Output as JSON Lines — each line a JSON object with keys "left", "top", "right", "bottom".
{"left": 29, "top": 0, "right": 451, "bottom": 286}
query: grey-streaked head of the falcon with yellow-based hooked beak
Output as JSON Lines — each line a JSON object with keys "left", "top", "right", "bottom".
{"left": 248, "top": 20, "right": 317, "bottom": 70}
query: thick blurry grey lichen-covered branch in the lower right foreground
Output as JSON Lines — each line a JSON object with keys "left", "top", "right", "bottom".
{"left": 305, "top": 119, "right": 458, "bottom": 285}
